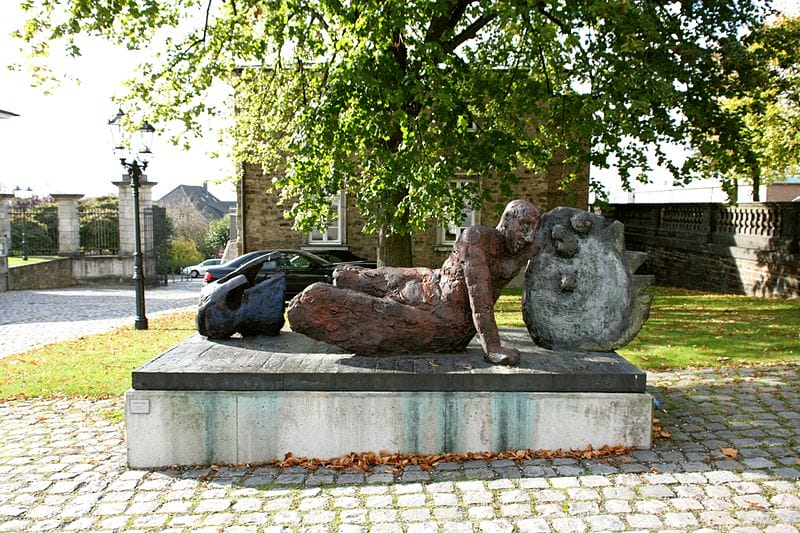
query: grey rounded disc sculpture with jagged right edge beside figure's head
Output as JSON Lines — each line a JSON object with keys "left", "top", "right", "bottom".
{"left": 522, "top": 207, "right": 653, "bottom": 352}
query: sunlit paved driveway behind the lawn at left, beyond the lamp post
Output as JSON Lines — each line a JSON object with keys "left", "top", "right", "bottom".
{"left": 0, "top": 281, "right": 202, "bottom": 357}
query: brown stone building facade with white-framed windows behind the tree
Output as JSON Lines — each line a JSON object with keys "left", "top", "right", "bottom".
{"left": 237, "top": 157, "right": 589, "bottom": 267}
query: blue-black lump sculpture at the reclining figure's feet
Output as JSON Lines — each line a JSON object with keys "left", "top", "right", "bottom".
{"left": 195, "top": 252, "right": 286, "bottom": 339}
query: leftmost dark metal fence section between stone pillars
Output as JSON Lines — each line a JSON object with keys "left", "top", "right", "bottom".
{"left": 9, "top": 204, "right": 58, "bottom": 256}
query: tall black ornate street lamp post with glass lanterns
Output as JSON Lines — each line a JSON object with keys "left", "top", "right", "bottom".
{"left": 108, "top": 109, "right": 156, "bottom": 329}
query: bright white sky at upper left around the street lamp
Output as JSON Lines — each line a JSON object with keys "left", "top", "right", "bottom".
{"left": 0, "top": 0, "right": 236, "bottom": 200}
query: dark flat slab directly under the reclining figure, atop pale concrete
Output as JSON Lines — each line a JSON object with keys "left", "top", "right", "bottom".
{"left": 132, "top": 328, "right": 647, "bottom": 392}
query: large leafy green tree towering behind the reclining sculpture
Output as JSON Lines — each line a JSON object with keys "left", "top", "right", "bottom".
{"left": 14, "top": 0, "right": 764, "bottom": 265}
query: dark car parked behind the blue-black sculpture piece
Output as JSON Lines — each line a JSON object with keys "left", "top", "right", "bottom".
{"left": 203, "top": 250, "right": 337, "bottom": 300}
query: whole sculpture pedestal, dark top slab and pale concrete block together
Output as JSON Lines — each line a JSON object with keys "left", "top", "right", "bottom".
{"left": 125, "top": 329, "right": 652, "bottom": 468}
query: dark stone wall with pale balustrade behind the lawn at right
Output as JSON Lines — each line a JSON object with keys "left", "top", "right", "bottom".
{"left": 604, "top": 203, "right": 800, "bottom": 298}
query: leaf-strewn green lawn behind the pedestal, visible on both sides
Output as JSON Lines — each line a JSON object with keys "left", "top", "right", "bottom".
{"left": 0, "top": 287, "right": 800, "bottom": 399}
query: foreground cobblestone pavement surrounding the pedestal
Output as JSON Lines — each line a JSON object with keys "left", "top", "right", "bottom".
{"left": 0, "top": 366, "right": 800, "bottom": 533}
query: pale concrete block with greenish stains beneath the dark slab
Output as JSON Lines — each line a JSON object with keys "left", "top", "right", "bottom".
{"left": 125, "top": 389, "right": 652, "bottom": 468}
